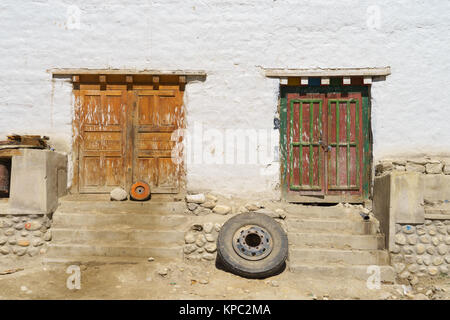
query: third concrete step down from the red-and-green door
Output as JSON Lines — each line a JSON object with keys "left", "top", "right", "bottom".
{"left": 288, "top": 232, "right": 384, "bottom": 250}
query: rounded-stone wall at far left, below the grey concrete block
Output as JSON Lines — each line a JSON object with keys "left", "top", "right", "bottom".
{"left": 0, "top": 214, "right": 52, "bottom": 259}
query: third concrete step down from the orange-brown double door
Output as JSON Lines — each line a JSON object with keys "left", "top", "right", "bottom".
{"left": 52, "top": 228, "right": 184, "bottom": 245}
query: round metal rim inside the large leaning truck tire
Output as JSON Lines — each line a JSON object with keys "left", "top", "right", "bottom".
{"left": 233, "top": 225, "right": 273, "bottom": 261}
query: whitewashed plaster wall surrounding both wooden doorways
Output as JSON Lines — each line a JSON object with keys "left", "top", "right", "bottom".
{"left": 0, "top": 0, "right": 450, "bottom": 196}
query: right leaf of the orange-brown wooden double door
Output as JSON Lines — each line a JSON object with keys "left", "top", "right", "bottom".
{"left": 133, "top": 89, "right": 182, "bottom": 193}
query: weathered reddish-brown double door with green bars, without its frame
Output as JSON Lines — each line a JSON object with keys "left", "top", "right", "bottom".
{"left": 286, "top": 92, "right": 363, "bottom": 202}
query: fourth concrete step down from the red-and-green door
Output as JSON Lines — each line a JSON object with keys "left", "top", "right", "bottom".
{"left": 289, "top": 248, "right": 389, "bottom": 265}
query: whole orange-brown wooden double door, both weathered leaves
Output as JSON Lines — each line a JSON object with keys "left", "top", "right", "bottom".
{"left": 74, "top": 84, "right": 183, "bottom": 193}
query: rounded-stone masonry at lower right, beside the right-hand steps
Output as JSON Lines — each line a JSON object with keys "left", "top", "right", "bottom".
{"left": 391, "top": 220, "right": 450, "bottom": 281}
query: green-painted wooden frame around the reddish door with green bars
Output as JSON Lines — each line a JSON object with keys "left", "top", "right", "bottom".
{"left": 279, "top": 85, "right": 373, "bottom": 203}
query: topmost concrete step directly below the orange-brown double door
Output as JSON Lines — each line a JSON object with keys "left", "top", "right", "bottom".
{"left": 58, "top": 200, "right": 186, "bottom": 215}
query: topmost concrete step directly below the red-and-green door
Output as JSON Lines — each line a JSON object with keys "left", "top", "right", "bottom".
{"left": 284, "top": 204, "right": 362, "bottom": 219}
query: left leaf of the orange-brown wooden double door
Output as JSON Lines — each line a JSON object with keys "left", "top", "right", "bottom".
{"left": 76, "top": 90, "right": 127, "bottom": 193}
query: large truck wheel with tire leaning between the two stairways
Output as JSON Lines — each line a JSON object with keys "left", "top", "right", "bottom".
{"left": 217, "top": 212, "right": 288, "bottom": 278}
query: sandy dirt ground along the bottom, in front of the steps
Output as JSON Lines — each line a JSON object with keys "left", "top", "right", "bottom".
{"left": 0, "top": 260, "right": 450, "bottom": 300}
